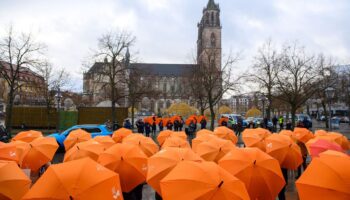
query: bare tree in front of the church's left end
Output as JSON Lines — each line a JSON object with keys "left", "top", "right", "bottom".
{"left": 95, "top": 31, "right": 135, "bottom": 123}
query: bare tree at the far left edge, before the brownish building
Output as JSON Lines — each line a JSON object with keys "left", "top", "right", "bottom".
{"left": 0, "top": 27, "right": 44, "bottom": 132}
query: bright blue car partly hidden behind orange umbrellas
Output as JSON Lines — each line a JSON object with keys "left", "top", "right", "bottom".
{"left": 48, "top": 124, "right": 112, "bottom": 149}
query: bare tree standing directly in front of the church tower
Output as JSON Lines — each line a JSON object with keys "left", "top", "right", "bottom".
{"left": 192, "top": 49, "right": 239, "bottom": 130}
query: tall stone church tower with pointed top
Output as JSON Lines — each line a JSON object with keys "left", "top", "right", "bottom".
{"left": 197, "top": 0, "right": 222, "bottom": 70}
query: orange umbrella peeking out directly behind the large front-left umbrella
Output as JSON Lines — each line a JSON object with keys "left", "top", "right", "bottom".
{"left": 63, "top": 140, "right": 105, "bottom": 162}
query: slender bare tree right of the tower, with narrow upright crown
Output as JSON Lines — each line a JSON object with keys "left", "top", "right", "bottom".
{"left": 245, "top": 40, "right": 278, "bottom": 119}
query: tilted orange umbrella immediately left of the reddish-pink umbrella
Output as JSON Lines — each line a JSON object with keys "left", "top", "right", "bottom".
{"left": 265, "top": 134, "right": 303, "bottom": 170}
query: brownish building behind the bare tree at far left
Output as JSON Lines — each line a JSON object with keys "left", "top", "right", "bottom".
{"left": 0, "top": 62, "right": 47, "bottom": 107}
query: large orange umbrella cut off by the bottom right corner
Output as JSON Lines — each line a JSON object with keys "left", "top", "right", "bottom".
{"left": 296, "top": 151, "right": 350, "bottom": 200}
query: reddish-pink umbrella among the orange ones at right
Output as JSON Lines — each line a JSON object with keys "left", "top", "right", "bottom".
{"left": 306, "top": 138, "right": 344, "bottom": 158}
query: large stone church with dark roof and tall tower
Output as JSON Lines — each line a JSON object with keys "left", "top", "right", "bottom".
{"left": 83, "top": 0, "right": 222, "bottom": 113}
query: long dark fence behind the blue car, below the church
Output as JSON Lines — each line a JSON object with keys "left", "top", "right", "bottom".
{"left": 12, "top": 106, "right": 128, "bottom": 130}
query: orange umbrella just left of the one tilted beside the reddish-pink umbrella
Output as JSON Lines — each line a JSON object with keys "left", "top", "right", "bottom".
{"left": 242, "top": 129, "right": 266, "bottom": 151}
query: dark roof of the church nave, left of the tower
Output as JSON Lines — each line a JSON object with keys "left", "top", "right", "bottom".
{"left": 131, "top": 63, "right": 196, "bottom": 77}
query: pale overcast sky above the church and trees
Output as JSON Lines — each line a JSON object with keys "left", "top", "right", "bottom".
{"left": 0, "top": 0, "right": 350, "bottom": 90}
